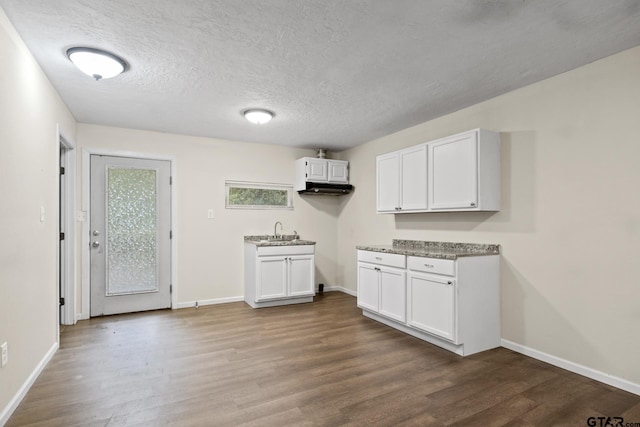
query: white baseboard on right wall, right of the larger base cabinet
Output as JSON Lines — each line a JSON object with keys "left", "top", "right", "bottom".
{"left": 502, "top": 339, "right": 640, "bottom": 395}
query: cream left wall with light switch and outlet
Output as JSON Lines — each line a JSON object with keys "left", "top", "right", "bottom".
{"left": 0, "top": 9, "right": 76, "bottom": 424}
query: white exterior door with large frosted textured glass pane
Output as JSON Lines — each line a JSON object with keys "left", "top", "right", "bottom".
{"left": 90, "top": 155, "right": 171, "bottom": 317}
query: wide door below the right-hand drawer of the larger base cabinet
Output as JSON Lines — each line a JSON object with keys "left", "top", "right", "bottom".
{"left": 407, "top": 272, "right": 457, "bottom": 343}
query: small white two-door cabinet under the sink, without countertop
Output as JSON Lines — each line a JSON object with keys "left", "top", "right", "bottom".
{"left": 244, "top": 243, "right": 315, "bottom": 308}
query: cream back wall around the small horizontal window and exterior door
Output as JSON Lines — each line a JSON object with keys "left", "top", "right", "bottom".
{"left": 78, "top": 124, "right": 338, "bottom": 310}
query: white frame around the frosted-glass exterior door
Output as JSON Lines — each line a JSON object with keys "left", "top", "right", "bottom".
{"left": 81, "top": 147, "right": 178, "bottom": 319}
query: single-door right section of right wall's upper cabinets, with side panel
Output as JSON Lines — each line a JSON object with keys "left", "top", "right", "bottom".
{"left": 428, "top": 130, "right": 500, "bottom": 211}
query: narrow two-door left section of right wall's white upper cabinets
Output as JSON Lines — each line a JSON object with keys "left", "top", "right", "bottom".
{"left": 376, "top": 144, "right": 427, "bottom": 213}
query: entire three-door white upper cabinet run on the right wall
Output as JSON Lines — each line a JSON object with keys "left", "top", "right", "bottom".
{"left": 376, "top": 129, "right": 500, "bottom": 213}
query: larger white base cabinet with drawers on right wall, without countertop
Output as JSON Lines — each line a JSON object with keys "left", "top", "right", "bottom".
{"left": 358, "top": 250, "right": 500, "bottom": 356}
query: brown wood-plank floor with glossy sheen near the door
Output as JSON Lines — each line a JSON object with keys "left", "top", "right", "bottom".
{"left": 7, "top": 292, "right": 640, "bottom": 426}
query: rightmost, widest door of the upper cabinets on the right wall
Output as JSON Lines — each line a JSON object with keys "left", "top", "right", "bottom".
{"left": 429, "top": 132, "right": 478, "bottom": 209}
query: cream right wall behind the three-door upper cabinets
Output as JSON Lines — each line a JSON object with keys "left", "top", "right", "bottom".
{"left": 338, "top": 47, "right": 640, "bottom": 384}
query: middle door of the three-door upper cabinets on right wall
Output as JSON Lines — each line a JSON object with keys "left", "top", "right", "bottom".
{"left": 399, "top": 145, "right": 427, "bottom": 211}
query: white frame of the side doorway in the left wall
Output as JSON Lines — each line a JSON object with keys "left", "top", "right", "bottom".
{"left": 56, "top": 124, "right": 78, "bottom": 325}
